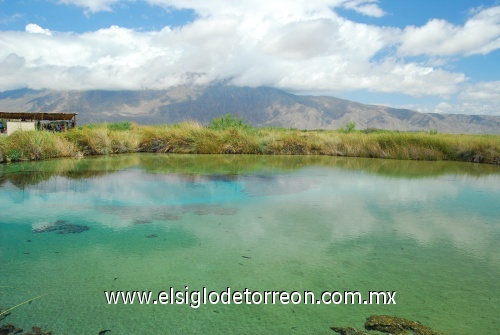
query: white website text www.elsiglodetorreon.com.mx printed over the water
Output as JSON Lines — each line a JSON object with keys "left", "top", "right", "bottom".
{"left": 104, "top": 286, "right": 396, "bottom": 308}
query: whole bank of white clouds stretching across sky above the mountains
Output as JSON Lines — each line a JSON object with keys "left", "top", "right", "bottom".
{"left": 0, "top": 0, "right": 500, "bottom": 115}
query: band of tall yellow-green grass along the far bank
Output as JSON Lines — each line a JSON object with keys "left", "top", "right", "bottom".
{"left": 0, "top": 115, "right": 500, "bottom": 165}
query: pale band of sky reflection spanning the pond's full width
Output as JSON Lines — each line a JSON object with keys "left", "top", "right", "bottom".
{"left": 0, "top": 164, "right": 500, "bottom": 266}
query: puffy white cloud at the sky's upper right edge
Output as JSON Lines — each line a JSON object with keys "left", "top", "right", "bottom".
{"left": 398, "top": 6, "right": 500, "bottom": 56}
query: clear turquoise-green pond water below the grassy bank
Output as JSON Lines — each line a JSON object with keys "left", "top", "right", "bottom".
{"left": 0, "top": 154, "right": 500, "bottom": 335}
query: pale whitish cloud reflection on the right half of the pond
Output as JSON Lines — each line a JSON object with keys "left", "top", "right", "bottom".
{"left": 176, "top": 170, "right": 500, "bottom": 270}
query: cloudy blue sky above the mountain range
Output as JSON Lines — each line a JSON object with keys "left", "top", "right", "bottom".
{"left": 0, "top": 0, "right": 500, "bottom": 116}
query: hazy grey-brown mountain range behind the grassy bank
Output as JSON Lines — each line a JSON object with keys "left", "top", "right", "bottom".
{"left": 0, "top": 84, "right": 500, "bottom": 134}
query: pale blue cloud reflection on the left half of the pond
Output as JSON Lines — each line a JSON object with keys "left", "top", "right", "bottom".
{"left": 0, "top": 170, "right": 244, "bottom": 228}
